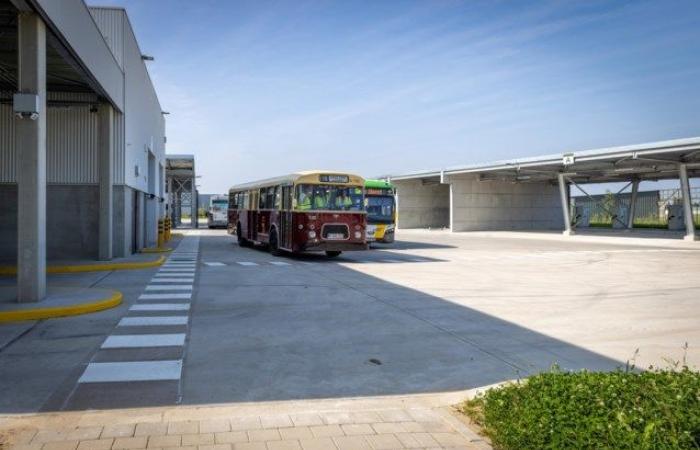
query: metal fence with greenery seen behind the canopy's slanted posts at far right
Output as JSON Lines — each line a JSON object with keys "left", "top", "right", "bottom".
{"left": 571, "top": 188, "right": 700, "bottom": 224}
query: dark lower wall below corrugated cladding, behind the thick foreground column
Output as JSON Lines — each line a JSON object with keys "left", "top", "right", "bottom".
{"left": 0, "top": 184, "right": 99, "bottom": 263}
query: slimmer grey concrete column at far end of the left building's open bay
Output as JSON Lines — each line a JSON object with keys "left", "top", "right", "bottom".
{"left": 98, "top": 103, "right": 114, "bottom": 260}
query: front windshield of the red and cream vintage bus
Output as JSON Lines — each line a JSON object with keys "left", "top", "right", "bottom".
{"left": 296, "top": 184, "right": 364, "bottom": 211}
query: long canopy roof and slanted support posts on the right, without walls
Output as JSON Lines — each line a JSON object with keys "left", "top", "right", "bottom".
{"left": 385, "top": 137, "right": 700, "bottom": 240}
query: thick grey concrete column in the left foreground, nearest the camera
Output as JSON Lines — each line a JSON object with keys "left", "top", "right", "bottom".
{"left": 16, "top": 12, "right": 46, "bottom": 302}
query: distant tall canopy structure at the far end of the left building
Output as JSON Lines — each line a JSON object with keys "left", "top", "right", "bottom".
{"left": 165, "top": 155, "right": 199, "bottom": 228}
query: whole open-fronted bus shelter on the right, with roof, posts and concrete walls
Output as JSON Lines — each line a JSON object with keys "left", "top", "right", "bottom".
{"left": 387, "top": 138, "right": 700, "bottom": 240}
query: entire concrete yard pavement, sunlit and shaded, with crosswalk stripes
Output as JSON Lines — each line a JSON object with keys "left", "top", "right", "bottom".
{"left": 0, "top": 230, "right": 700, "bottom": 450}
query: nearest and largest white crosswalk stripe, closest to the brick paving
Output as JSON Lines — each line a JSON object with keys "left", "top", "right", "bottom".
{"left": 78, "top": 360, "right": 182, "bottom": 383}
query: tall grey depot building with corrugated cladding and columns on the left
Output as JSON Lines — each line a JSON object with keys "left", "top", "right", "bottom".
{"left": 0, "top": 0, "right": 165, "bottom": 301}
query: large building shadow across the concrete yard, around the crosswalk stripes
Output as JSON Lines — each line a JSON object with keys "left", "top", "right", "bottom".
{"left": 0, "top": 235, "right": 623, "bottom": 413}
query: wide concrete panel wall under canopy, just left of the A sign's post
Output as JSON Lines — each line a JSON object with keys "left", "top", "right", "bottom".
{"left": 447, "top": 175, "right": 564, "bottom": 231}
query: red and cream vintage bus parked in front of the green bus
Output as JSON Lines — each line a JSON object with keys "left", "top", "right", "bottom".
{"left": 228, "top": 172, "right": 368, "bottom": 256}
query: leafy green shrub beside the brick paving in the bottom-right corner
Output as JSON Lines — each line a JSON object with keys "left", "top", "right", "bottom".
{"left": 461, "top": 368, "right": 700, "bottom": 450}
